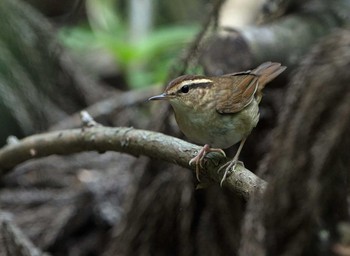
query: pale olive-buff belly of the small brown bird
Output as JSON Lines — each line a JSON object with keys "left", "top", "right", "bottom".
{"left": 176, "top": 101, "right": 259, "bottom": 148}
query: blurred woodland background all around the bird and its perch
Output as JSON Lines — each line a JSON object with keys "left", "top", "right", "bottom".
{"left": 0, "top": 0, "right": 350, "bottom": 256}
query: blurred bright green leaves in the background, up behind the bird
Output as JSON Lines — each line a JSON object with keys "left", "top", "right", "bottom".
{"left": 60, "top": 1, "right": 198, "bottom": 87}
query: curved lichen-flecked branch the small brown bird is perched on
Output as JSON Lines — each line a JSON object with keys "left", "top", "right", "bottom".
{"left": 0, "top": 127, "right": 266, "bottom": 199}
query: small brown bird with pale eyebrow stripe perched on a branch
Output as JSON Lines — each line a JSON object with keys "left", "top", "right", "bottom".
{"left": 149, "top": 62, "right": 286, "bottom": 185}
